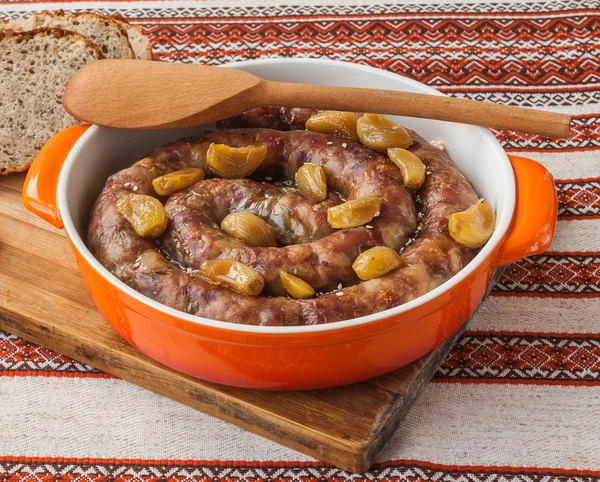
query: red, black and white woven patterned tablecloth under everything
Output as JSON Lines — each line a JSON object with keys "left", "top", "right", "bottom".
{"left": 0, "top": 0, "right": 600, "bottom": 482}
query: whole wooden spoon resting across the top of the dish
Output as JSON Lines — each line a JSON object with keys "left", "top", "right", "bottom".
{"left": 63, "top": 60, "right": 571, "bottom": 137}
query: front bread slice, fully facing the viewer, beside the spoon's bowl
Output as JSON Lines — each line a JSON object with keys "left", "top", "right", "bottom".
{"left": 0, "top": 28, "right": 102, "bottom": 174}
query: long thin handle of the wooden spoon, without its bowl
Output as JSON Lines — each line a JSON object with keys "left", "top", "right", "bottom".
{"left": 255, "top": 80, "right": 571, "bottom": 138}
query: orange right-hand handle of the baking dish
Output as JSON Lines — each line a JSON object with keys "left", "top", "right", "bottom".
{"left": 493, "top": 156, "right": 558, "bottom": 267}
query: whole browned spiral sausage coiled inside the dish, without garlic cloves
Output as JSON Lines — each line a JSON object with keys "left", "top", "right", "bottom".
{"left": 89, "top": 115, "right": 477, "bottom": 325}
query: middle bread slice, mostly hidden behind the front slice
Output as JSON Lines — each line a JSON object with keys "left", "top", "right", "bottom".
{"left": 4, "top": 10, "right": 135, "bottom": 59}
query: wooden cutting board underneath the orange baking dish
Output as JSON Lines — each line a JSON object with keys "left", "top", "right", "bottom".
{"left": 0, "top": 175, "right": 466, "bottom": 472}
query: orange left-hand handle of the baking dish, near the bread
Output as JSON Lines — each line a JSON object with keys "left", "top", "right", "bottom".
{"left": 22, "top": 125, "right": 90, "bottom": 229}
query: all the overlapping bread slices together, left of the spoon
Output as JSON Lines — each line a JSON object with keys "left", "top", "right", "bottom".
{"left": 0, "top": 10, "right": 152, "bottom": 174}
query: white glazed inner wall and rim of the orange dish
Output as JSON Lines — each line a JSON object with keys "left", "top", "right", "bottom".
{"left": 57, "top": 59, "right": 515, "bottom": 333}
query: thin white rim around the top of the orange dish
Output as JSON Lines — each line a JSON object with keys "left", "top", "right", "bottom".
{"left": 57, "top": 59, "right": 516, "bottom": 335}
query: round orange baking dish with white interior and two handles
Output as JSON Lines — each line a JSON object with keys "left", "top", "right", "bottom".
{"left": 23, "top": 59, "right": 557, "bottom": 390}
